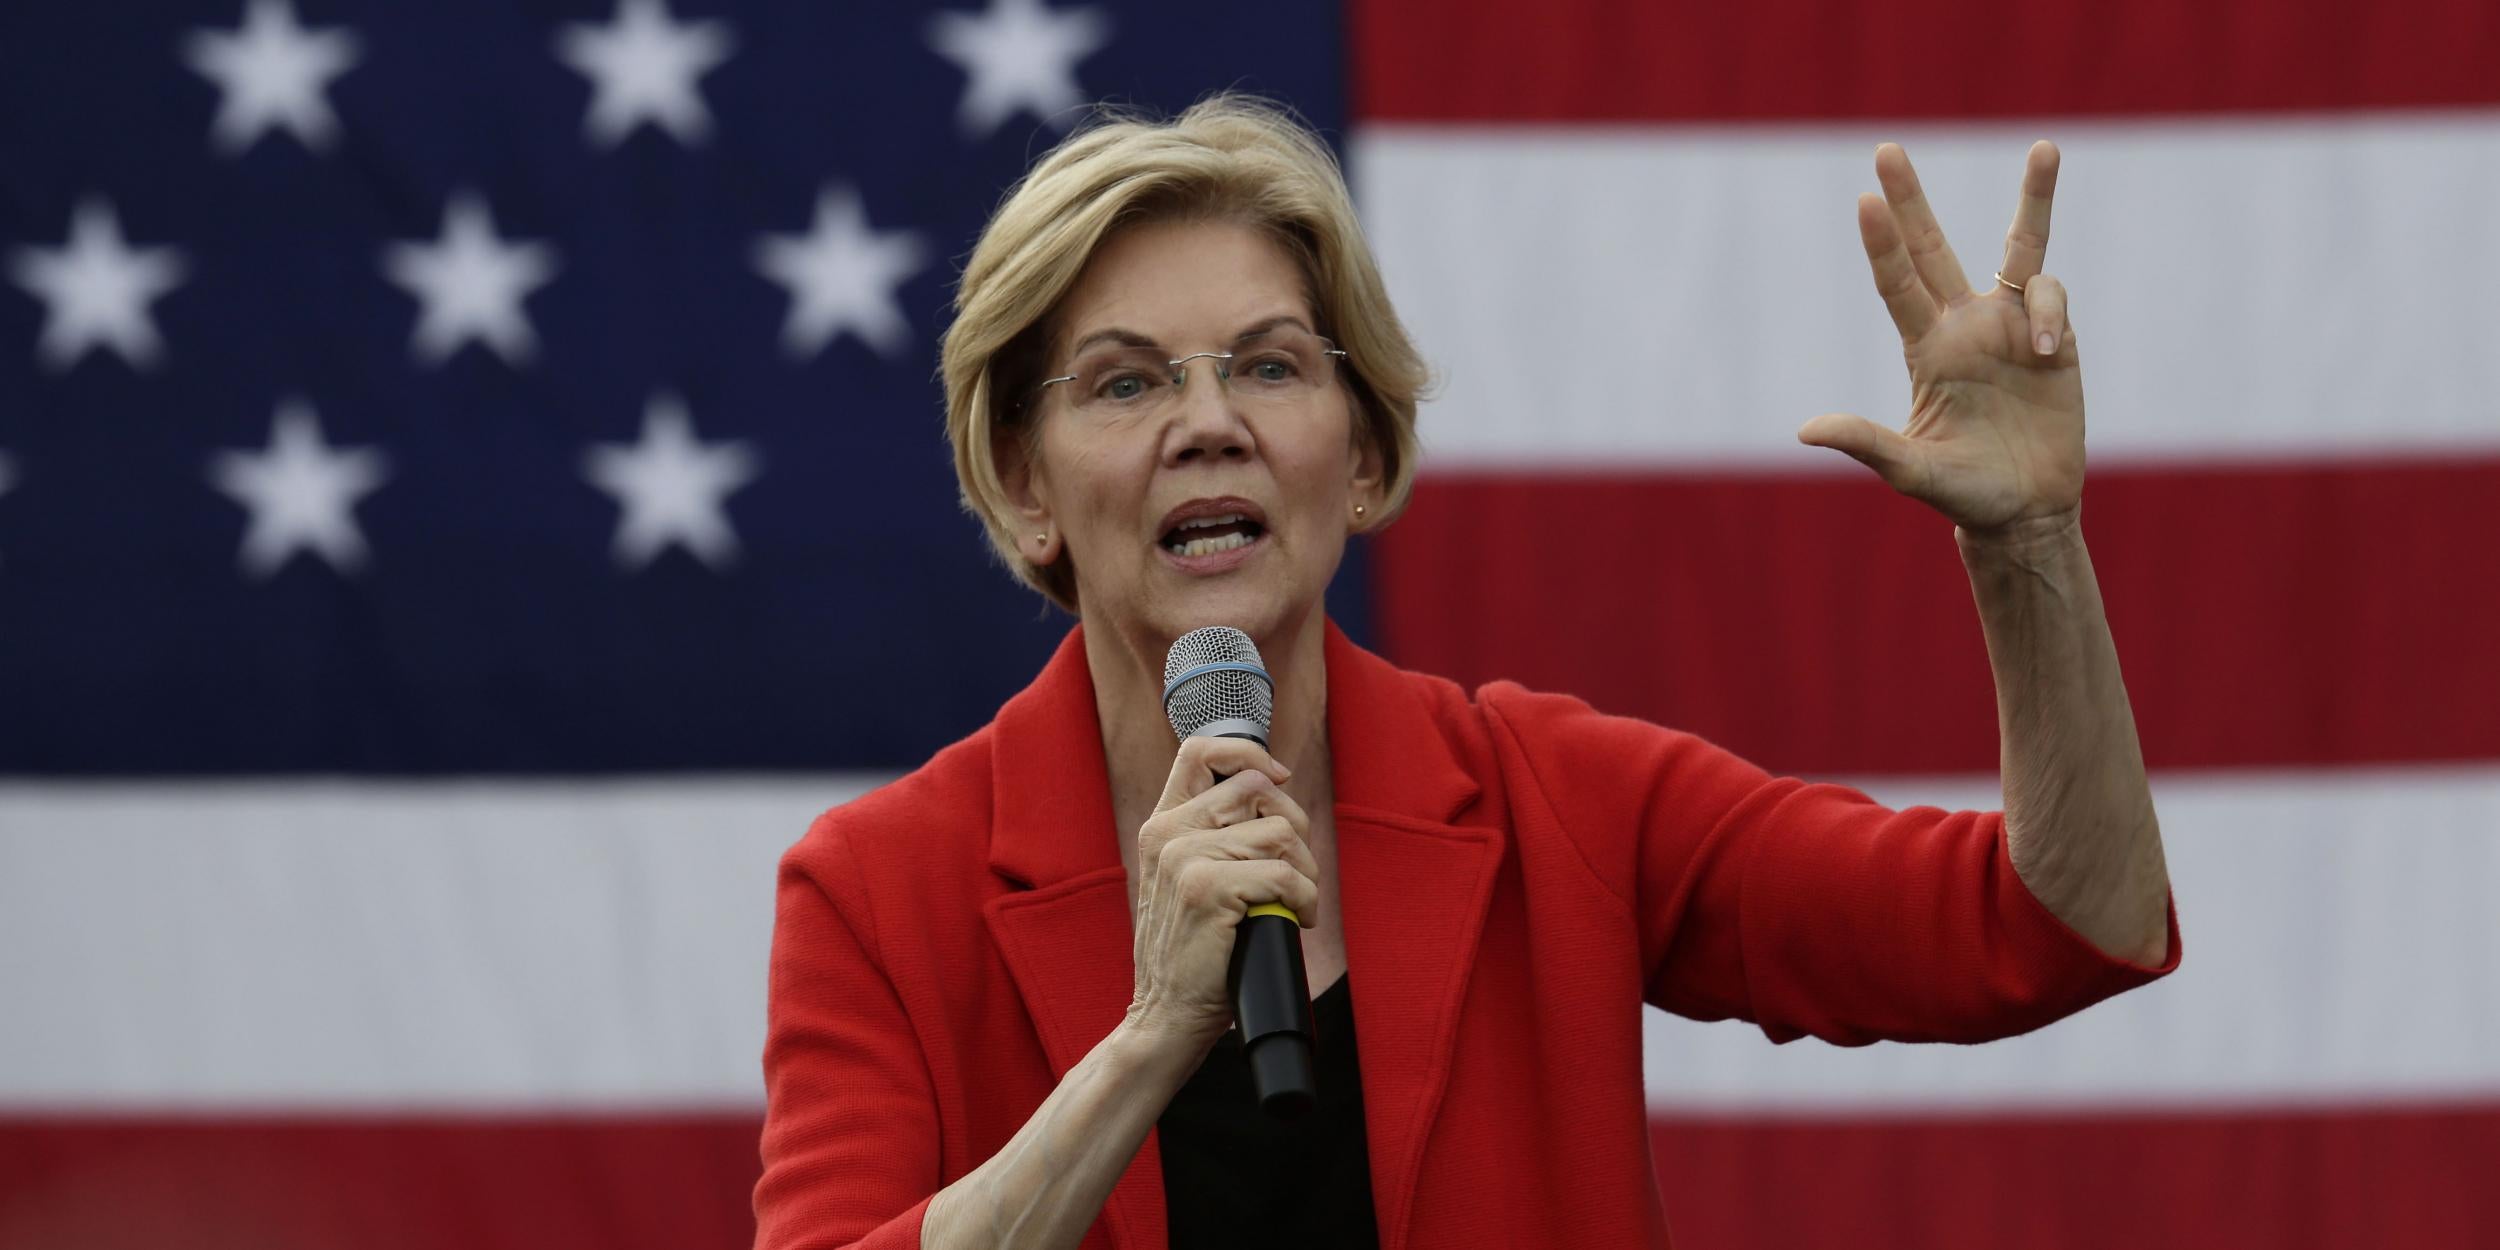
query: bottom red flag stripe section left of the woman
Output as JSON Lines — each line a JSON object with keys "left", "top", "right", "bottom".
{"left": 0, "top": 1113, "right": 763, "bottom": 1250}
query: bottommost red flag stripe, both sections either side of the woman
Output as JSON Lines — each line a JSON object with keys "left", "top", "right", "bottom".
{"left": 0, "top": 1103, "right": 2500, "bottom": 1250}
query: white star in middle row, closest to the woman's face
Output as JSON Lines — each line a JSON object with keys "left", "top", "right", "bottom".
{"left": 755, "top": 188, "right": 925, "bottom": 358}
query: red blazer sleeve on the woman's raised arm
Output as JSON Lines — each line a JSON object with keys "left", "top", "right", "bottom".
{"left": 1488, "top": 683, "right": 2180, "bottom": 1045}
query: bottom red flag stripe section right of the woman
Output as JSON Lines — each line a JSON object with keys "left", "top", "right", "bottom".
{"left": 1650, "top": 1105, "right": 2500, "bottom": 1250}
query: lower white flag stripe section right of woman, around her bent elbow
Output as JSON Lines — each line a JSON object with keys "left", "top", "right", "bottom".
{"left": 1645, "top": 768, "right": 2500, "bottom": 1113}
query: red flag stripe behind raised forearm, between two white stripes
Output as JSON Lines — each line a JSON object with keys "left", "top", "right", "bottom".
{"left": 1373, "top": 460, "right": 2500, "bottom": 773}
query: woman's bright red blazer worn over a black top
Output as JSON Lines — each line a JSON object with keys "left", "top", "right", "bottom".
{"left": 755, "top": 625, "right": 2180, "bottom": 1250}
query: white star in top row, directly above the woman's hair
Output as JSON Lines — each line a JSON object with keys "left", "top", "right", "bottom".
{"left": 928, "top": 0, "right": 1110, "bottom": 140}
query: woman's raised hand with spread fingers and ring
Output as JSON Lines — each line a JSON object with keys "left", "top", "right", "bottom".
{"left": 1798, "top": 140, "right": 2083, "bottom": 530}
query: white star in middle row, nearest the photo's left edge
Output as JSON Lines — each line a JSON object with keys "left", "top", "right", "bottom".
{"left": 8, "top": 195, "right": 183, "bottom": 370}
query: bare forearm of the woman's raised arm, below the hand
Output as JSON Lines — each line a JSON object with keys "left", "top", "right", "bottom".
{"left": 1955, "top": 513, "right": 2170, "bottom": 965}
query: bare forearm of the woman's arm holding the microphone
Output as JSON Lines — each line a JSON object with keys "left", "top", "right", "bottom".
{"left": 920, "top": 1023, "right": 1205, "bottom": 1250}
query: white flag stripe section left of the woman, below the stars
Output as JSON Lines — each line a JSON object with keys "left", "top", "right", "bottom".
{"left": 0, "top": 775, "right": 885, "bottom": 1108}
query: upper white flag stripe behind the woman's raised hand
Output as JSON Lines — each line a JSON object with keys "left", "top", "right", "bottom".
{"left": 1350, "top": 113, "right": 2500, "bottom": 473}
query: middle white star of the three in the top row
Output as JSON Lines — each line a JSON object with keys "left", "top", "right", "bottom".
{"left": 555, "top": 0, "right": 735, "bottom": 148}
